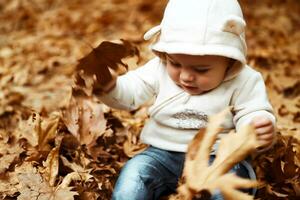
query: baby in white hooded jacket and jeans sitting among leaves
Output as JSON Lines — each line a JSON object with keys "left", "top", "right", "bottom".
{"left": 92, "top": 0, "right": 275, "bottom": 200}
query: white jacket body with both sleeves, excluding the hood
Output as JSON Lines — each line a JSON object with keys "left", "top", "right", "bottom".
{"left": 101, "top": 57, "right": 275, "bottom": 152}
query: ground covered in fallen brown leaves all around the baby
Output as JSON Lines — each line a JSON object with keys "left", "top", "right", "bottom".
{"left": 0, "top": 0, "right": 300, "bottom": 199}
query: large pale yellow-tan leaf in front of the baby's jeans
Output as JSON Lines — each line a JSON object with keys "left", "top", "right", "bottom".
{"left": 178, "top": 110, "right": 257, "bottom": 200}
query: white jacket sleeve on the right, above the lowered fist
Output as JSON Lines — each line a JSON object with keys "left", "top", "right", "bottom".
{"left": 233, "top": 72, "right": 275, "bottom": 130}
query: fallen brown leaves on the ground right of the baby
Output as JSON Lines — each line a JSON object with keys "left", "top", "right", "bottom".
{"left": 242, "top": 0, "right": 300, "bottom": 199}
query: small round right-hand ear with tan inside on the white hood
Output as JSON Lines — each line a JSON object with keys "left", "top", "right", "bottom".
{"left": 222, "top": 15, "right": 246, "bottom": 35}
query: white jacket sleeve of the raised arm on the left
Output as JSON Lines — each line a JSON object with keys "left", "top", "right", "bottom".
{"left": 100, "top": 58, "right": 162, "bottom": 110}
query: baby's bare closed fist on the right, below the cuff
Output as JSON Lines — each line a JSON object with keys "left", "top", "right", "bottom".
{"left": 251, "top": 117, "right": 275, "bottom": 148}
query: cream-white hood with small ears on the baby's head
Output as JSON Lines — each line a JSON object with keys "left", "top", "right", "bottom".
{"left": 144, "top": 0, "right": 247, "bottom": 80}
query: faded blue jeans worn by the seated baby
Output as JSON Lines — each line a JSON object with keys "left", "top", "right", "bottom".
{"left": 112, "top": 147, "right": 253, "bottom": 200}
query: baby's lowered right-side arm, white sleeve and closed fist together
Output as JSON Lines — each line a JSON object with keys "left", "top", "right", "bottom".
{"left": 233, "top": 69, "right": 275, "bottom": 149}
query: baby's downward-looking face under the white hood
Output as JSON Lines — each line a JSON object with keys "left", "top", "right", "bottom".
{"left": 166, "top": 54, "right": 230, "bottom": 95}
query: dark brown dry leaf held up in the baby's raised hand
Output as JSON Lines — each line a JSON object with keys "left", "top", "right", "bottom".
{"left": 75, "top": 40, "right": 139, "bottom": 94}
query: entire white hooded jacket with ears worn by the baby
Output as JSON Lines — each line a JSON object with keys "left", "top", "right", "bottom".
{"left": 101, "top": 0, "right": 275, "bottom": 152}
